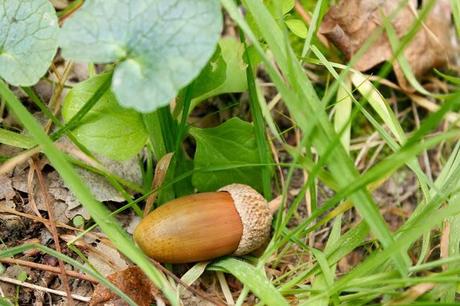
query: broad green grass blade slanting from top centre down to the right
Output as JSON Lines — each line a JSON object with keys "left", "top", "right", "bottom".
{"left": 234, "top": 0, "right": 409, "bottom": 273}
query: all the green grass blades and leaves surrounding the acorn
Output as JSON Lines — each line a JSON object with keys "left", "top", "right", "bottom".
{"left": 0, "top": 0, "right": 460, "bottom": 305}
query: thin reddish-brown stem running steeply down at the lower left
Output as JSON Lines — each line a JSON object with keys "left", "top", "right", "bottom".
{"left": 31, "top": 160, "right": 74, "bottom": 306}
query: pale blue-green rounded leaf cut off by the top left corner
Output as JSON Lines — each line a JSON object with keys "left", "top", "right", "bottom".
{"left": 0, "top": 0, "right": 59, "bottom": 86}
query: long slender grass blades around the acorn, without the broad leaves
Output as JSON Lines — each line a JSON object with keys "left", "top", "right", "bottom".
{"left": 0, "top": 0, "right": 460, "bottom": 306}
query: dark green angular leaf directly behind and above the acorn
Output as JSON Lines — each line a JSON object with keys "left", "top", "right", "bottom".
{"left": 190, "top": 118, "right": 262, "bottom": 191}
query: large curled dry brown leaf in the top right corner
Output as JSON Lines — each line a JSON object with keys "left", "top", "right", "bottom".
{"left": 320, "top": 0, "right": 451, "bottom": 86}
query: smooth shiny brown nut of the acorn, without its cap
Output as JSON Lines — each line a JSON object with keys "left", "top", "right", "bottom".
{"left": 134, "top": 192, "right": 243, "bottom": 263}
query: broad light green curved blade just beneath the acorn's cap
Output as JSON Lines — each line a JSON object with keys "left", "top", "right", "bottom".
{"left": 211, "top": 258, "right": 289, "bottom": 306}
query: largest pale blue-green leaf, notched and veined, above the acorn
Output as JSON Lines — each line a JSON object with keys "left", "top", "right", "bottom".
{"left": 60, "top": 0, "right": 222, "bottom": 112}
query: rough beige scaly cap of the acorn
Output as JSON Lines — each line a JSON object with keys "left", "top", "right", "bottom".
{"left": 219, "top": 184, "right": 272, "bottom": 256}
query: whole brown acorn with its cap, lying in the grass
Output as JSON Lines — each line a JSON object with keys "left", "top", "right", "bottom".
{"left": 134, "top": 184, "right": 277, "bottom": 263}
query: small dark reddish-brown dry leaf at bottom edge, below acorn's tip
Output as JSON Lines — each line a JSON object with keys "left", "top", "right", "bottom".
{"left": 90, "top": 267, "right": 159, "bottom": 306}
